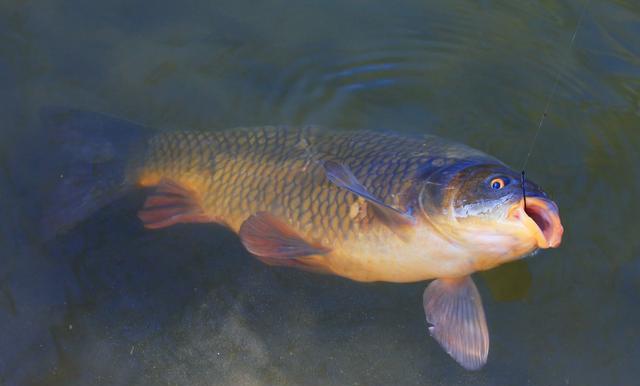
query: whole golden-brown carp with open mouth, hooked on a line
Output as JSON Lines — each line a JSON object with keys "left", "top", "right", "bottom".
{"left": 42, "top": 108, "right": 564, "bottom": 370}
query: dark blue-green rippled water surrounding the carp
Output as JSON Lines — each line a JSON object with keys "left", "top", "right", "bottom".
{"left": 0, "top": 0, "right": 640, "bottom": 385}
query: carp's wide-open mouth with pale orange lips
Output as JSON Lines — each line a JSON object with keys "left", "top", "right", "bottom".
{"left": 510, "top": 197, "right": 564, "bottom": 248}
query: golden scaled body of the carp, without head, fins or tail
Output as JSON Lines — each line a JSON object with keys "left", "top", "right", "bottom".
{"left": 129, "top": 127, "right": 482, "bottom": 282}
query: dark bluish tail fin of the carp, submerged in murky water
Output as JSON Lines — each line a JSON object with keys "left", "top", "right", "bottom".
{"left": 40, "top": 108, "right": 153, "bottom": 239}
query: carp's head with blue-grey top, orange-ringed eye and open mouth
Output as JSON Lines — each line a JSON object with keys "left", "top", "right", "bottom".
{"left": 419, "top": 161, "right": 563, "bottom": 269}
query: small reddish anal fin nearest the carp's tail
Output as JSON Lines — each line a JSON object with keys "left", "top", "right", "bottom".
{"left": 138, "top": 180, "right": 214, "bottom": 229}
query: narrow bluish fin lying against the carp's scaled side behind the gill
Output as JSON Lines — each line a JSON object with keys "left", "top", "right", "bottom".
{"left": 322, "top": 161, "right": 415, "bottom": 227}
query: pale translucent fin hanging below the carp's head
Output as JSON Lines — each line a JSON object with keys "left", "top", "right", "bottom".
{"left": 423, "top": 276, "right": 489, "bottom": 370}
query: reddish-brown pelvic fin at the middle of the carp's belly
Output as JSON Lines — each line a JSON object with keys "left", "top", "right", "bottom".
{"left": 239, "top": 212, "right": 329, "bottom": 259}
